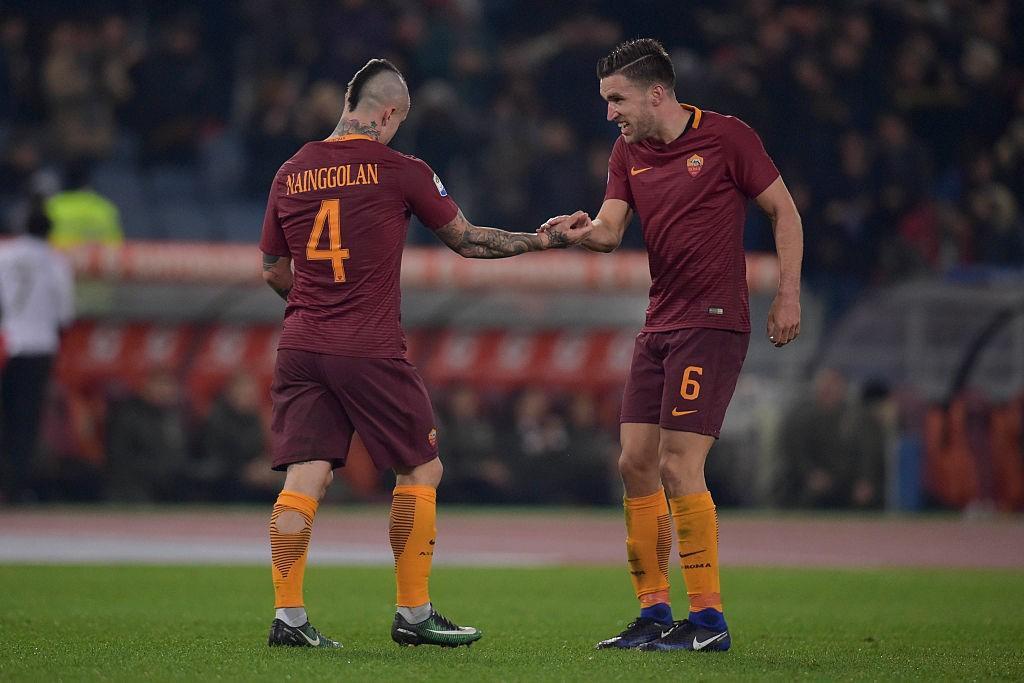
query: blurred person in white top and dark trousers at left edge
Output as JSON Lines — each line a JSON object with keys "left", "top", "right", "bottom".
{"left": 0, "top": 198, "right": 75, "bottom": 504}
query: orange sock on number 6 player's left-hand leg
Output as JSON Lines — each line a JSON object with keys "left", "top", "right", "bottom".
{"left": 624, "top": 488, "right": 672, "bottom": 607}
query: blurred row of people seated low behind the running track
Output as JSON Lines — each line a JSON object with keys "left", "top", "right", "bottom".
{"left": 25, "top": 370, "right": 913, "bottom": 510}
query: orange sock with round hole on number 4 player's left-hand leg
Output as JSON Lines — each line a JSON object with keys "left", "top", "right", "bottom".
{"left": 270, "top": 490, "right": 317, "bottom": 607}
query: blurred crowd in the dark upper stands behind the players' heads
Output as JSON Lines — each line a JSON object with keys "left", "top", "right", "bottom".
{"left": 0, "top": 0, "right": 1024, "bottom": 311}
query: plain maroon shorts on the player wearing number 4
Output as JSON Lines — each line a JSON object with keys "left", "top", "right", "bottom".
{"left": 270, "top": 348, "right": 437, "bottom": 470}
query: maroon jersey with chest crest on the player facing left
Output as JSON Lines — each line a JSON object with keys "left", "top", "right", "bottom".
{"left": 604, "top": 104, "right": 779, "bottom": 332}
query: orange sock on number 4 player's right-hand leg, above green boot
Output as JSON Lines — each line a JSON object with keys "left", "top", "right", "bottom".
{"left": 388, "top": 486, "right": 437, "bottom": 607}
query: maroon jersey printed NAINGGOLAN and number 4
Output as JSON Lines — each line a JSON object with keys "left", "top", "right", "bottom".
{"left": 260, "top": 135, "right": 459, "bottom": 358}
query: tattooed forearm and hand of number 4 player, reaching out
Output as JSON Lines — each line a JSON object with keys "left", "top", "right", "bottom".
{"left": 436, "top": 211, "right": 591, "bottom": 258}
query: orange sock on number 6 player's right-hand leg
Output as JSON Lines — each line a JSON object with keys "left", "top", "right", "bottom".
{"left": 669, "top": 492, "right": 722, "bottom": 612}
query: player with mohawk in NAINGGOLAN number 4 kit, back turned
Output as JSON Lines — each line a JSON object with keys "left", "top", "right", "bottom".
{"left": 260, "top": 59, "right": 590, "bottom": 647}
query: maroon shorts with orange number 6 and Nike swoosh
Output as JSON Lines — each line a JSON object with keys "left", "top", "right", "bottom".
{"left": 618, "top": 328, "right": 751, "bottom": 438}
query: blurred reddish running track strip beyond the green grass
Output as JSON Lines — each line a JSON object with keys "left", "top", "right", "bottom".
{"left": 0, "top": 506, "right": 1024, "bottom": 569}
